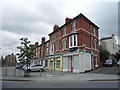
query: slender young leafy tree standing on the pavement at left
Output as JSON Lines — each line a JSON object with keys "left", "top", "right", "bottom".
{"left": 17, "top": 38, "right": 35, "bottom": 76}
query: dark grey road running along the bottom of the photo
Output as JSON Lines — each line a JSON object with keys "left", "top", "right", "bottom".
{"left": 3, "top": 81, "right": 120, "bottom": 88}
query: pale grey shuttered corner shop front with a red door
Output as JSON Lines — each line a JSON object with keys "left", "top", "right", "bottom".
{"left": 62, "top": 51, "right": 92, "bottom": 73}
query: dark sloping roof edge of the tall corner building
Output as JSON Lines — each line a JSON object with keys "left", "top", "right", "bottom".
{"left": 49, "top": 13, "right": 99, "bottom": 36}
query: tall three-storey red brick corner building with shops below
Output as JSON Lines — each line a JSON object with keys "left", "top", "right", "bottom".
{"left": 48, "top": 14, "right": 100, "bottom": 73}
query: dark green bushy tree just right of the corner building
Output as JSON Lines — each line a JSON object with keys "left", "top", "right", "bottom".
{"left": 100, "top": 46, "right": 110, "bottom": 63}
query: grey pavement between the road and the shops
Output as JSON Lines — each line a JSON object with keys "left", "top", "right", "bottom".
{"left": 2, "top": 67, "right": 120, "bottom": 82}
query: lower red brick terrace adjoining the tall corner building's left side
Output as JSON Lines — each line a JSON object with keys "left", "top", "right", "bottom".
{"left": 31, "top": 37, "right": 49, "bottom": 67}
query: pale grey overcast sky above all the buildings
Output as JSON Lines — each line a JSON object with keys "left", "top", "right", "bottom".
{"left": 0, "top": 0, "right": 118, "bottom": 55}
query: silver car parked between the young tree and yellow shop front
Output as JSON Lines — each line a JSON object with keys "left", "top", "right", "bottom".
{"left": 24, "top": 64, "right": 45, "bottom": 71}
